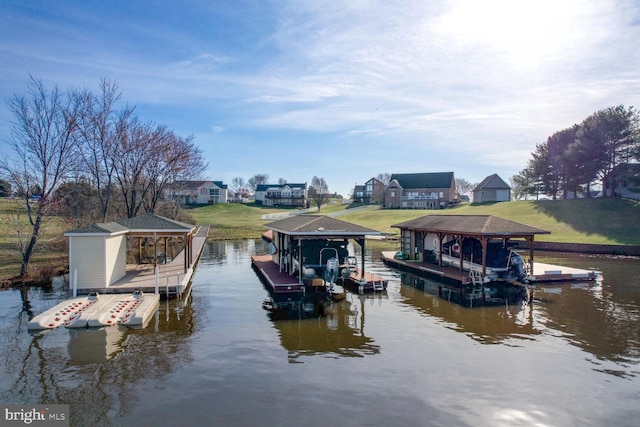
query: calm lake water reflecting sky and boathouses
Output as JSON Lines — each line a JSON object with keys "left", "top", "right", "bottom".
{"left": 0, "top": 240, "right": 640, "bottom": 426}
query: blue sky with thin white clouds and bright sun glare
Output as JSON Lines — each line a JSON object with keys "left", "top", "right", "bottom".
{"left": 0, "top": 0, "right": 640, "bottom": 196}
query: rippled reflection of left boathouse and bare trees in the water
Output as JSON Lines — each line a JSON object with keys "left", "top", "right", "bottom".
{"left": 0, "top": 289, "right": 194, "bottom": 425}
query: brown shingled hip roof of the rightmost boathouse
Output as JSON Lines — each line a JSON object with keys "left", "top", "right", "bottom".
{"left": 392, "top": 215, "right": 550, "bottom": 237}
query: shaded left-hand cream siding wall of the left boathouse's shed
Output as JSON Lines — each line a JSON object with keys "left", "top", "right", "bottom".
{"left": 69, "top": 236, "right": 106, "bottom": 289}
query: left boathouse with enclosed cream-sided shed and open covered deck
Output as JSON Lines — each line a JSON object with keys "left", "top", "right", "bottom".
{"left": 64, "top": 214, "right": 195, "bottom": 292}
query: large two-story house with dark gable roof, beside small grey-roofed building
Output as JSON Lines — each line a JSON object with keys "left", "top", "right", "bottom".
{"left": 384, "top": 172, "right": 457, "bottom": 209}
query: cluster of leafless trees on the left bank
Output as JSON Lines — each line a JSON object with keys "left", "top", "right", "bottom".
{"left": 0, "top": 77, "right": 207, "bottom": 277}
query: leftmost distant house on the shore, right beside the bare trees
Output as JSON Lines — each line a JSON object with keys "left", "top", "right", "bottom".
{"left": 164, "top": 181, "right": 229, "bottom": 205}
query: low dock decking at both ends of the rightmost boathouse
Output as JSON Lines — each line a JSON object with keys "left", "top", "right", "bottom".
{"left": 382, "top": 251, "right": 599, "bottom": 285}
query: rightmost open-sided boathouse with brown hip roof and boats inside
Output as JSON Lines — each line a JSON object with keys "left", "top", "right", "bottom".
{"left": 392, "top": 215, "right": 550, "bottom": 278}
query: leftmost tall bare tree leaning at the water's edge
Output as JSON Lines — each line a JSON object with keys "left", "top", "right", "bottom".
{"left": 0, "top": 77, "right": 79, "bottom": 277}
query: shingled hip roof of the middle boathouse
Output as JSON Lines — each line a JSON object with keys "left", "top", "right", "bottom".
{"left": 265, "top": 215, "right": 381, "bottom": 238}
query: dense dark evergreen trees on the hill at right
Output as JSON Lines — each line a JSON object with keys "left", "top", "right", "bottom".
{"left": 511, "top": 105, "right": 640, "bottom": 200}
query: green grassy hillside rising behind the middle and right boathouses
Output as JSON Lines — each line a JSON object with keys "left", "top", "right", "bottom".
{"left": 189, "top": 199, "right": 640, "bottom": 245}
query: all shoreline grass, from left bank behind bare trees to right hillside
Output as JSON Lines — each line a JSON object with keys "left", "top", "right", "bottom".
{"left": 0, "top": 199, "right": 640, "bottom": 279}
